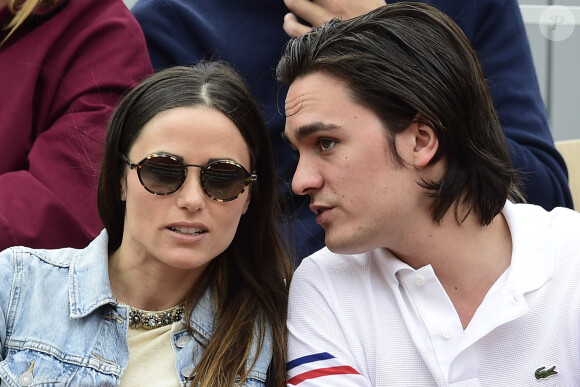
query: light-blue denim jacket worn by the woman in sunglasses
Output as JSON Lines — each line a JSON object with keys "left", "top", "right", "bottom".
{"left": 0, "top": 231, "right": 272, "bottom": 387}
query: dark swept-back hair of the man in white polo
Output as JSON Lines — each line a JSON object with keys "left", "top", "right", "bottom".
{"left": 276, "top": 2, "right": 523, "bottom": 225}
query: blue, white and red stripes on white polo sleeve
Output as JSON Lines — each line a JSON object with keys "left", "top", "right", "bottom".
{"left": 286, "top": 352, "right": 359, "bottom": 386}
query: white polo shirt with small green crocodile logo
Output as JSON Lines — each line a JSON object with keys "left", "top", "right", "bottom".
{"left": 287, "top": 203, "right": 580, "bottom": 387}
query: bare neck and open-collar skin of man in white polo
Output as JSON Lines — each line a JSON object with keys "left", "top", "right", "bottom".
{"left": 391, "top": 213, "right": 512, "bottom": 328}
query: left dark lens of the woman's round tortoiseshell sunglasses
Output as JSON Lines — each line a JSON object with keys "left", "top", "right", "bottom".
{"left": 139, "top": 156, "right": 185, "bottom": 195}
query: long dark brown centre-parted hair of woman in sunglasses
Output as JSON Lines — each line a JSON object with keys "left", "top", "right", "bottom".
{"left": 98, "top": 62, "right": 291, "bottom": 386}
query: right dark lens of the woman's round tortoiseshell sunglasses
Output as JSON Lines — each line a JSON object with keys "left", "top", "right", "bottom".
{"left": 202, "top": 161, "right": 248, "bottom": 201}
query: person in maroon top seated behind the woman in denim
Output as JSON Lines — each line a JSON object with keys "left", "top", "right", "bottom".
{"left": 0, "top": 0, "right": 153, "bottom": 249}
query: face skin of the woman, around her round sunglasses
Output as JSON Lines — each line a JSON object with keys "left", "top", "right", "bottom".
{"left": 120, "top": 107, "right": 252, "bottom": 275}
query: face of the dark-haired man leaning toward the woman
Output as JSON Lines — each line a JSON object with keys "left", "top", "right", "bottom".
{"left": 284, "top": 72, "right": 420, "bottom": 253}
